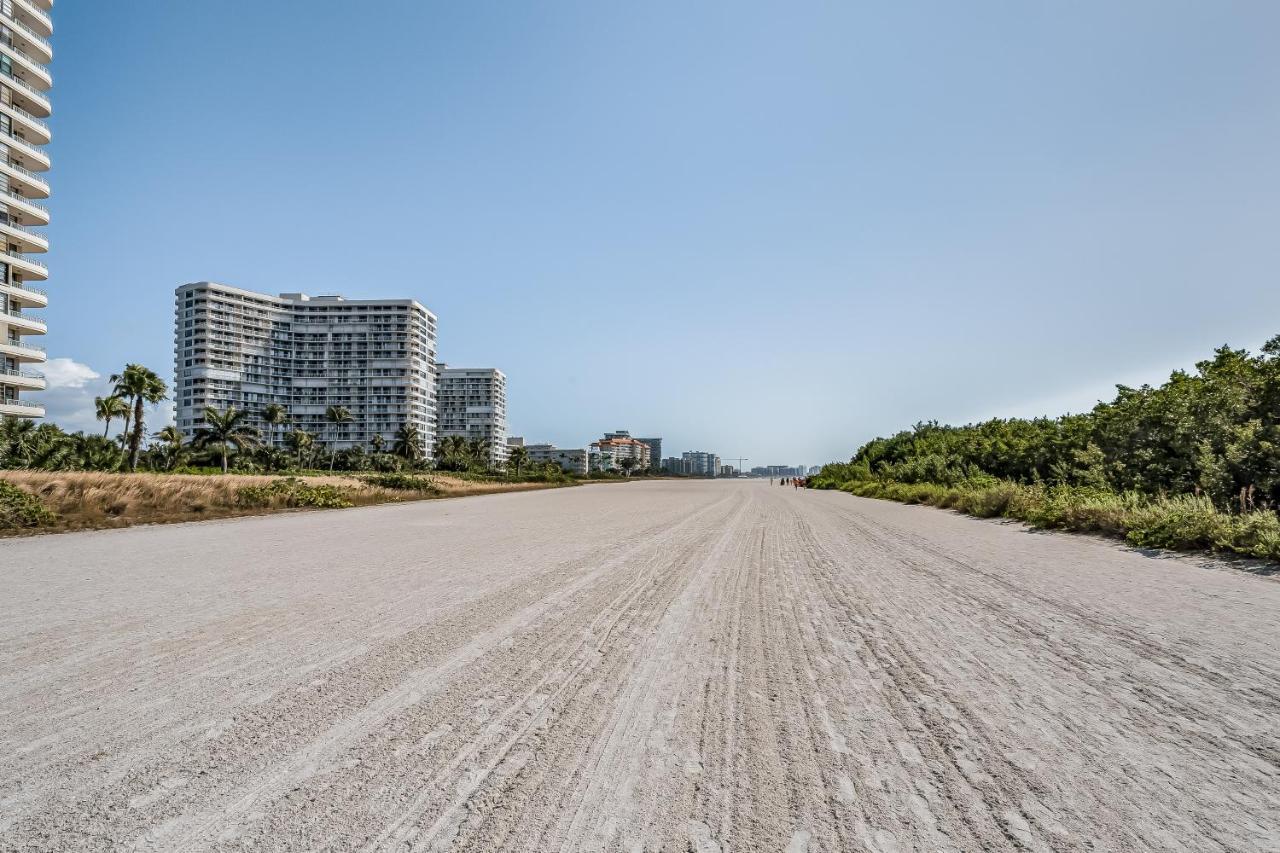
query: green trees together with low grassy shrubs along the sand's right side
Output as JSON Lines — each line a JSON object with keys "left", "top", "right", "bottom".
{"left": 812, "top": 337, "right": 1280, "bottom": 561}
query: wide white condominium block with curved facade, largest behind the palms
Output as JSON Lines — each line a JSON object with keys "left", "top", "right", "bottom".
{"left": 174, "top": 280, "right": 435, "bottom": 452}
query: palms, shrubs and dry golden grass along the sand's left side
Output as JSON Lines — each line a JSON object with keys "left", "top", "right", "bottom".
{"left": 0, "top": 364, "right": 577, "bottom": 534}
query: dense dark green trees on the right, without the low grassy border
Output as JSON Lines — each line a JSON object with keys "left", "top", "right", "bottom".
{"left": 819, "top": 336, "right": 1280, "bottom": 512}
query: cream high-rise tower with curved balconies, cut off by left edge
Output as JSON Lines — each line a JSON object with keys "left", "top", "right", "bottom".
{"left": 0, "top": 0, "right": 54, "bottom": 419}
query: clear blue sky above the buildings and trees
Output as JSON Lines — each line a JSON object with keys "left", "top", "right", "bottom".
{"left": 37, "top": 0, "right": 1280, "bottom": 464}
